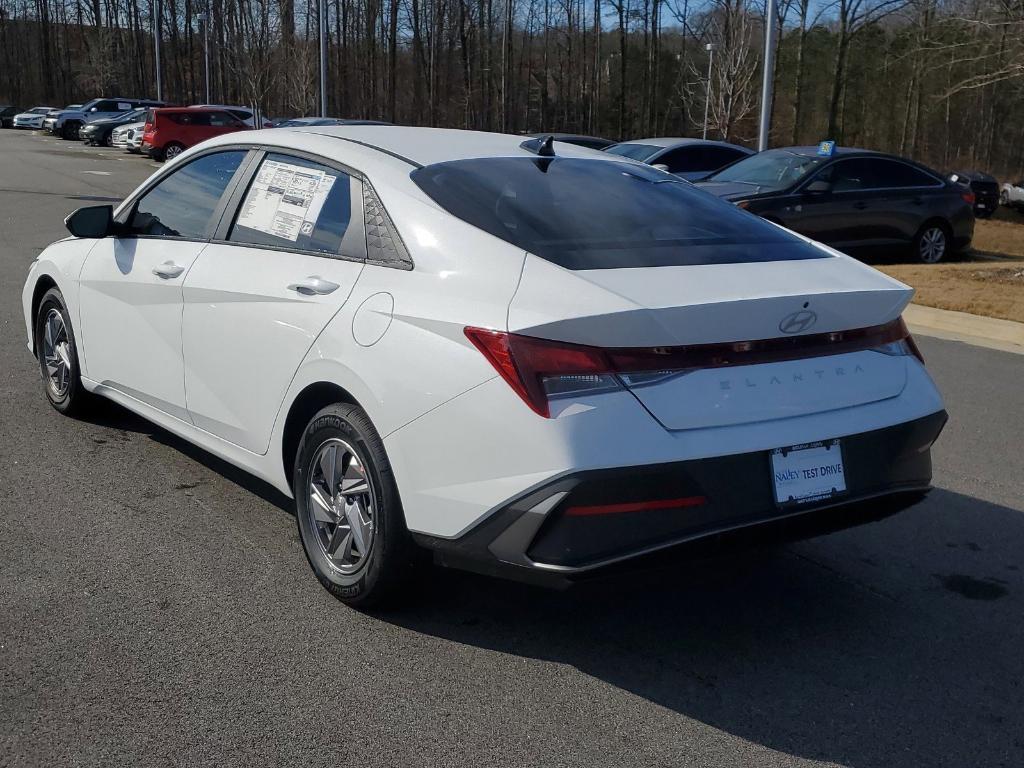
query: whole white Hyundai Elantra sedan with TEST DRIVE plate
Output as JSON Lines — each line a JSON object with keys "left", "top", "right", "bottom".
{"left": 24, "top": 126, "right": 946, "bottom": 604}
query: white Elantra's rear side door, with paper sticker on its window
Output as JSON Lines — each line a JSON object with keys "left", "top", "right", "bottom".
{"left": 182, "top": 153, "right": 366, "bottom": 454}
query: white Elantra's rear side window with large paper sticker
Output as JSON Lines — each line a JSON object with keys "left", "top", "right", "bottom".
{"left": 227, "top": 154, "right": 366, "bottom": 258}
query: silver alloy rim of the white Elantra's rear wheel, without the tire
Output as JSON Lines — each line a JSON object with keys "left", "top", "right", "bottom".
{"left": 306, "top": 438, "right": 376, "bottom": 575}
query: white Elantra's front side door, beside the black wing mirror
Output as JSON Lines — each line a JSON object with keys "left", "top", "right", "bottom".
{"left": 80, "top": 151, "right": 247, "bottom": 420}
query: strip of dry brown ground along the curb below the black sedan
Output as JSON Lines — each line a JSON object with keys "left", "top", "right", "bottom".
{"left": 878, "top": 259, "right": 1024, "bottom": 323}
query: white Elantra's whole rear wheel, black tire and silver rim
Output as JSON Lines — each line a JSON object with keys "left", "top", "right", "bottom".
{"left": 292, "top": 403, "right": 421, "bottom": 607}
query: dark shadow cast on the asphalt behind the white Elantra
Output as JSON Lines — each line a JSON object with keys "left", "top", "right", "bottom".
{"left": 381, "top": 489, "right": 1024, "bottom": 766}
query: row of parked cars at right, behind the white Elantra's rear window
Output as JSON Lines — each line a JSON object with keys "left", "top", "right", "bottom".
{"left": 551, "top": 134, "right": 974, "bottom": 264}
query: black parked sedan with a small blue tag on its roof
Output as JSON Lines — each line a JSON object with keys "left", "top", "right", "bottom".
{"left": 697, "top": 146, "right": 974, "bottom": 264}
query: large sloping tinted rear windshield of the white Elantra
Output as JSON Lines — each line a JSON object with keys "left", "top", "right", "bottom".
{"left": 412, "top": 158, "right": 827, "bottom": 269}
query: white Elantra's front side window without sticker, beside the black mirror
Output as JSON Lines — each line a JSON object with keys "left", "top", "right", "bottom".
{"left": 128, "top": 151, "right": 246, "bottom": 240}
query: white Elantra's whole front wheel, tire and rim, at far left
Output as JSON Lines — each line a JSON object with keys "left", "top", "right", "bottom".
{"left": 36, "top": 288, "right": 89, "bottom": 416}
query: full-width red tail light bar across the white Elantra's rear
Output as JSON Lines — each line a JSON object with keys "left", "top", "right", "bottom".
{"left": 465, "top": 317, "right": 925, "bottom": 418}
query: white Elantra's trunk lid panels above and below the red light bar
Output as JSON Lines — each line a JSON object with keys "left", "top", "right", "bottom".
{"left": 509, "top": 256, "right": 912, "bottom": 430}
